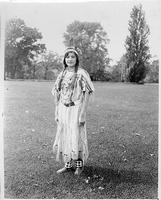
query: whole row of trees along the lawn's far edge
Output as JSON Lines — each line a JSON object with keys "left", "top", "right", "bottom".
{"left": 4, "top": 5, "right": 159, "bottom": 83}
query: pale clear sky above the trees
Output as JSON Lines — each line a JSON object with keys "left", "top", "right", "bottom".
{"left": 1, "top": 0, "right": 161, "bottom": 63}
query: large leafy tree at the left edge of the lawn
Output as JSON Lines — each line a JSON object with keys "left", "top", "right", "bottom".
{"left": 5, "top": 18, "right": 45, "bottom": 78}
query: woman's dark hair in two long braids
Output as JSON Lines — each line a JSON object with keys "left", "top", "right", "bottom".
{"left": 58, "top": 51, "right": 79, "bottom": 91}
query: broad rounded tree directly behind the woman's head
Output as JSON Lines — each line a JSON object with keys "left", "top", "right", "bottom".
{"left": 64, "top": 21, "right": 109, "bottom": 78}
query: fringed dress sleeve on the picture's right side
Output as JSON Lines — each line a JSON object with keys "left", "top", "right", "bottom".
{"left": 81, "top": 70, "right": 94, "bottom": 94}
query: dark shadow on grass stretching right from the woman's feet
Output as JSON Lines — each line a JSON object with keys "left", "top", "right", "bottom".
{"left": 82, "top": 166, "right": 158, "bottom": 185}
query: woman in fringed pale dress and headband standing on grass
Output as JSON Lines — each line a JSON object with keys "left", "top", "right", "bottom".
{"left": 52, "top": 48, "right": 94, "bottom": 175}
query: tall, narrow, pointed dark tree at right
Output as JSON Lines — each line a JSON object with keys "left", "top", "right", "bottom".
{"left": 125, "top": 5, "right": 150, "bottom": 83}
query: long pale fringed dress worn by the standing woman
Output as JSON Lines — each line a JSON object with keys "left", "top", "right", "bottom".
{"left": 52, "top": 67, "right": 94, "bottom": 163}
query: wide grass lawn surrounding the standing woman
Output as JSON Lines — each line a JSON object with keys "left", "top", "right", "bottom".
{"left": 4, "top": 81, "right": 158, "bottom": 199}
